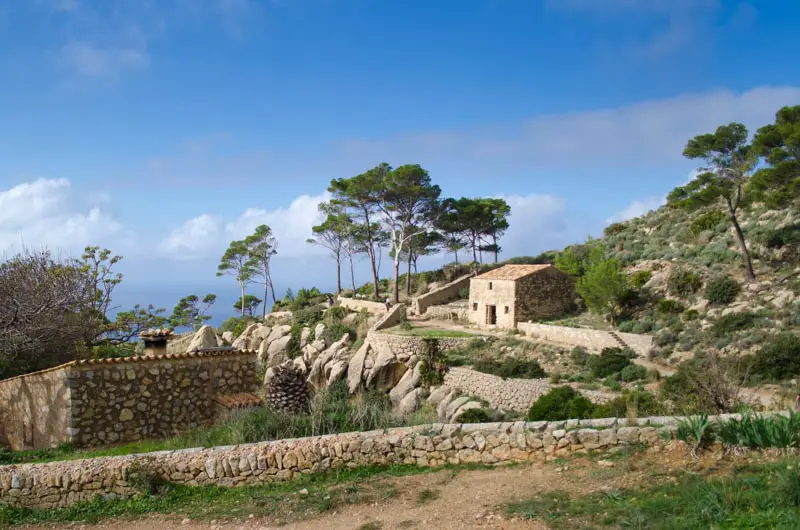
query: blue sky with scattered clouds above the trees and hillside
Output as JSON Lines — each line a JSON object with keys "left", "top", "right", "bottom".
{"left": 0, "top": 0, "right": 800, "bottom": 320}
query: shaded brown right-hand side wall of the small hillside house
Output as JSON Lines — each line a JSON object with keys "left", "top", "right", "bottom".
{"left": 514, "top": 267, "right": 575, "bottom": 323}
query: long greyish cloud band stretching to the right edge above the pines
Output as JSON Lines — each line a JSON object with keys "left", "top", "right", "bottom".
{"left": 340, "top": 87, "right": 800, "bottom": 171}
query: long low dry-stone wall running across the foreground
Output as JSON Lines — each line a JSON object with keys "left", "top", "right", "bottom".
{"left": 0, "top": 412, "right": 700, "bottom": 508}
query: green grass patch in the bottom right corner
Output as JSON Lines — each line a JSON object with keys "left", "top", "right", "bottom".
{"left": 506, "top": 458, "right": 800, "bottom": 530}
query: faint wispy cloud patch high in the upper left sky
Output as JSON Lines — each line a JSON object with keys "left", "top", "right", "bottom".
{"left": 61, "top": 42, "right": 150, "bottom": 78}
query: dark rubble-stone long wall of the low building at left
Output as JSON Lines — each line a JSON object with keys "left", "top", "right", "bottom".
{"left": 67, "top": 352, "right": 260, "bottom": 446}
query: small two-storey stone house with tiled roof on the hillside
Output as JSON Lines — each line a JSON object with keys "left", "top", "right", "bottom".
{"left": 468, "top": 265, "right": 575, "bottom": 329}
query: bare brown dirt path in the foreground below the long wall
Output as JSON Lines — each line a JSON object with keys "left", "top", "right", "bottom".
{"left": 18, "top": 451, "right": 686, "bottom": 530}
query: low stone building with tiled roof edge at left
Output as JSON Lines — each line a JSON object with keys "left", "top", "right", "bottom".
{"left": 0, "top": 348, "right": 261, "bottom": 450}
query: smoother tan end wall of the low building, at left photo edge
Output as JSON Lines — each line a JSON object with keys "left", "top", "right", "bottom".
{"left": 0, "top": 366, "right": 70, "bottom": 451}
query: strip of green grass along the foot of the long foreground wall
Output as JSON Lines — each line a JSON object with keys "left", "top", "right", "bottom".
{"left": 0, "top": 464, "right": 488, "bottom": 526}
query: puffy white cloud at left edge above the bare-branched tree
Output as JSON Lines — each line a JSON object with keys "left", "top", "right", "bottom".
{"left": 0, "top": 179, "right": 126, "bottom": 253}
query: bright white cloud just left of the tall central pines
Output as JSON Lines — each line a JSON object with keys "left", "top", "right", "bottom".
{"left": 160, "top": 193, "right": 330, "bottom": 260}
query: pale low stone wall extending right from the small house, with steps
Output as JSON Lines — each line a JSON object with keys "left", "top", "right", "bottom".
{"left": 517, "top": 322, "right": 653, "bottom": 356}
